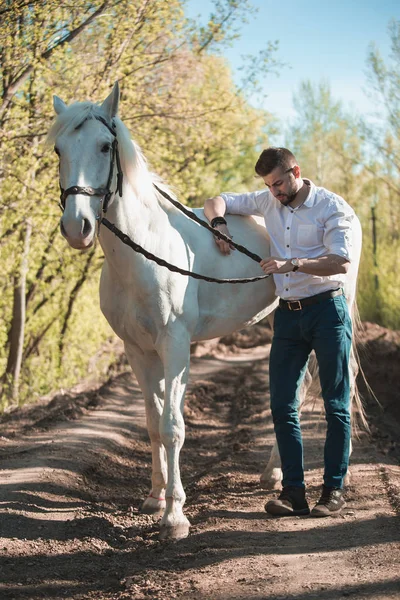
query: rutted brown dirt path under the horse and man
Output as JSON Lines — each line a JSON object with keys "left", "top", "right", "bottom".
{"left": 0, "top": 338, "right": 400, "bottom": 600}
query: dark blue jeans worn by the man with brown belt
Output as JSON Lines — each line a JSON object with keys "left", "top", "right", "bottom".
{"left": 269, "top": 296, "right": 352, "bottom": 488}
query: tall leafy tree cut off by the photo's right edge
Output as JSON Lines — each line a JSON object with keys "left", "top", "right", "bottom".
{"left": 360, "top": 19, "right": 400, "bottom": 328}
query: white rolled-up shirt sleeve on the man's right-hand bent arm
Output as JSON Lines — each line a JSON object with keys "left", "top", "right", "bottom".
{"left": 324, "top": 198, "right": 355, "bottom": 262}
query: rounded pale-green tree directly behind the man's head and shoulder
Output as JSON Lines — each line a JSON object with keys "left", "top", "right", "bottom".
{"left": 289, "top": 81, "right": 383, "bottom": 323}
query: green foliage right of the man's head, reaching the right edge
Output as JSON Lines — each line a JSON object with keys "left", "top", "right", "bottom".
{"left": 288, "top": 21, "right": 400, "bottom": 328}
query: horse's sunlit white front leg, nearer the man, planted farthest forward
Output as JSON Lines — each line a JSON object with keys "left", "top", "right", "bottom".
{"left": 160, "top": 327, "right": 190, "bottom": 539}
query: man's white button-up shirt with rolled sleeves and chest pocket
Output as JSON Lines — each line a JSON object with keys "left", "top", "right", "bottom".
{"left": 220, "top": 179, "right": 355, "bottom": 300}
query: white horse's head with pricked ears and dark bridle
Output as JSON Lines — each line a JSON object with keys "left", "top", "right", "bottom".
{"left": 49, "top": 84, "right": 121, "bottom": 249}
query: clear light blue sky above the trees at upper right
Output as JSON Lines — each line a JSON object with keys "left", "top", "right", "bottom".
{"left": 186, "top": 0, "right": 400, "bottom": 131}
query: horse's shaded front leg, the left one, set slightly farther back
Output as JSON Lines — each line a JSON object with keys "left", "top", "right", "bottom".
{"left": 125, "top": 344, "right": 167, "bottom": 515}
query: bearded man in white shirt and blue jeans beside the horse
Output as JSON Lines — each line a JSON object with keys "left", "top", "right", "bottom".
{"left": 204, "top": 148, "right": 355, "bottom": 517}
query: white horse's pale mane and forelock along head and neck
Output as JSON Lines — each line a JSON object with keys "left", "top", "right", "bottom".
{"left": 46, "top": 102, "right": 174, "bottom": 203}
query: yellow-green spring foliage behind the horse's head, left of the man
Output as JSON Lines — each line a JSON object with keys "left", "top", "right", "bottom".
{"left": 0, "top": 0, "right": 274, "bottom": 408}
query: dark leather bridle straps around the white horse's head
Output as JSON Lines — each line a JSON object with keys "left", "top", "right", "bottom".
{"left": 60, "top": 115, "right": 123, "bottom": 213}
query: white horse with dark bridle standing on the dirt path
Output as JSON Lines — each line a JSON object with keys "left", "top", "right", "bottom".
{"left": 48, "top": 84, "right": 364, "bottom": 539}
